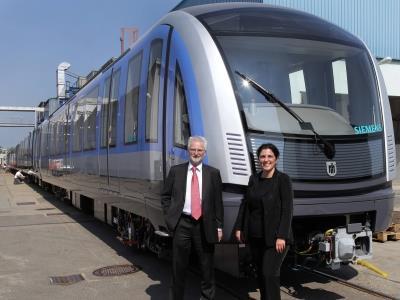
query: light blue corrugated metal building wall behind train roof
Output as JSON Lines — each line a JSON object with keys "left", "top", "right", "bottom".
{"left": 264, "top": 0, "right": 400, "bottom": 60}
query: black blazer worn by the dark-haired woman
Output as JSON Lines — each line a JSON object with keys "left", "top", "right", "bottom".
{"left": 235, "top": 169, "right": 293, "bottom": 247}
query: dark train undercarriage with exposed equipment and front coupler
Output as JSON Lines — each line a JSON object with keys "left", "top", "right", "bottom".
{"left": 25, "top": 172, "right": 375, "bottom": 276}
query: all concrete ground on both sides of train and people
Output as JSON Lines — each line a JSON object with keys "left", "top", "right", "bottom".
{"left": 0, "top": 173, "right": 400, "bottom": 300}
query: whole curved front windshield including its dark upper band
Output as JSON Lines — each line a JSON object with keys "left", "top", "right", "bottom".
{"left": 201, "top": 10, "right": 383, "bottom": 136}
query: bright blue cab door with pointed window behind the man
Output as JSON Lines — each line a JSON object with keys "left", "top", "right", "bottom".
{"left": 164, "top": 31, "right": 203, "bottom": 176}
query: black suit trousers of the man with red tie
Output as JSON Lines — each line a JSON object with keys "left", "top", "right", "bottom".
{"left": 170, "top": 215, "right": 215, "bottom": 300}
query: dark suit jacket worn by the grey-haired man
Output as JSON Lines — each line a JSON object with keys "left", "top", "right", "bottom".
{"left": 161, "top": 163, "right": 224, "bottom": 243}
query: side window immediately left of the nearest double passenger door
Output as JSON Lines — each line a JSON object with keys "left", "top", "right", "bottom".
{"left": 83, "top": 87, "right": 99, "bottom": 150}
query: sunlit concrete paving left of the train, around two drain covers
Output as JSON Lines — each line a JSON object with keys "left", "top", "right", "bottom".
{"left": 0, "top": 173, "right": 236, "bottom": 300}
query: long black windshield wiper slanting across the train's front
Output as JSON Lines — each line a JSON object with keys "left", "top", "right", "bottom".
{"left": 235, "top": 70, "right": 336, "bottom": 159}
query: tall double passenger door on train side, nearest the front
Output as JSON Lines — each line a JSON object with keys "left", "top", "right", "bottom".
{"left": 98, "top": 69, "right": 121, "bottom": 192}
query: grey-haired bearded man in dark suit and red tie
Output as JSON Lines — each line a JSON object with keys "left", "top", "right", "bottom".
{"left": 161, "top": 136, "right": 224, "bottom": 300}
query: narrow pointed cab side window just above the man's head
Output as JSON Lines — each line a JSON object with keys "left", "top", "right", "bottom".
{"left": 174, "top": 65, "right": 190, "bottom": 149}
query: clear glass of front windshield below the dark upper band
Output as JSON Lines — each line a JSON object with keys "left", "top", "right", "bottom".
{"left": 222, "top": 36, "right": 382, "bottom": 135}
